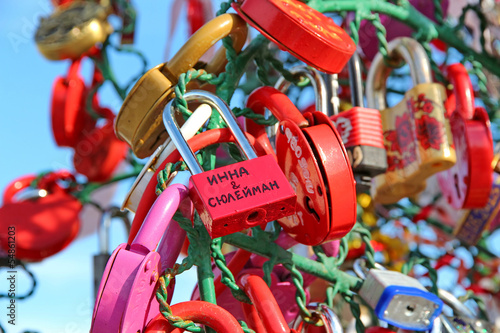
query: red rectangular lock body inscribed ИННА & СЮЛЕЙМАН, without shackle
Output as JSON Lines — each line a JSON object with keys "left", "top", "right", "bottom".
{"left": 190, "top": 155, "right": 296, "bottom": 238}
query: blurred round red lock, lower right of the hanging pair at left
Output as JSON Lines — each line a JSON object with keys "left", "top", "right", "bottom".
{"left": 73, "top": 108, "right": 128, "bottom": 182}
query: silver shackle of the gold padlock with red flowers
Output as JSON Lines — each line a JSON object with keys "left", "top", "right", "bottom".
{"left": 366, "top": 37, "right": 432, "bottom": 110}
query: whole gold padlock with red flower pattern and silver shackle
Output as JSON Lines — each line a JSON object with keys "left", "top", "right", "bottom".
{"left": 366, "top": 37, "right": 456, "bottom": 204}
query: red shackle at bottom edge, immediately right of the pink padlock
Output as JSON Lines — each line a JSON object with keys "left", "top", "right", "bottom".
{"left": 145, "top": 301, "right": 243, "bottom": 333}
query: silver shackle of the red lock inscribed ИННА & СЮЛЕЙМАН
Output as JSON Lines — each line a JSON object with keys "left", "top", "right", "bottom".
{"left": 163, "top": 90, "right": 257, "bottom": 175}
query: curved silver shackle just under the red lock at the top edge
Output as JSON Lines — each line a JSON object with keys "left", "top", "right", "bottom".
{"left": 274, "top": 65, "right": 330, "bottom": 116}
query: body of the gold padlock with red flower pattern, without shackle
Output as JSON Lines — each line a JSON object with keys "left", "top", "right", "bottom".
{"left": 372, "top": 83, "right": 456, "bottom": 204}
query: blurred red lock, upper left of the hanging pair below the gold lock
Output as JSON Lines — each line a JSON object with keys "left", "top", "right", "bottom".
{"left": 51, "top": 58, "right": 95, "bottom": 147}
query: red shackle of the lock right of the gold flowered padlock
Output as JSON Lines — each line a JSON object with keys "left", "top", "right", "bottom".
{"left": 447, "top": 63, "right": 475, "bottom": 119}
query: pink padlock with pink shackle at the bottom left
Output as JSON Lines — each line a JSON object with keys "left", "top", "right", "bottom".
{"left": 90, "top": 172, "right": 192, "bottom": 333}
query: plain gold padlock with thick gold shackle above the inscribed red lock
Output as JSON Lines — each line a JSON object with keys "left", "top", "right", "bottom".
{"left": 115, "top": 14, "right": 248, "bottom": 158}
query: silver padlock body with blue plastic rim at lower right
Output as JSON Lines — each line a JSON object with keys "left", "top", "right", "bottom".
{"left": 358, "top": 269, "right": 443, "bottom": 331}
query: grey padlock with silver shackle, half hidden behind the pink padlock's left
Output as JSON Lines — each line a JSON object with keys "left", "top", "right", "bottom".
{"left": 94, "top": 207, "right": 130, "bottom": 298}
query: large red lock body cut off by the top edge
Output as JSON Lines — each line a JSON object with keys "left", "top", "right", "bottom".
{"left": 232, "top": 0, "right": 356, "bottom": 74}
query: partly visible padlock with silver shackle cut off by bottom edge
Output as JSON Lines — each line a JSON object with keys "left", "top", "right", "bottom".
{"left": 293, "top": 303, "right": 344, "bottom": 333}
